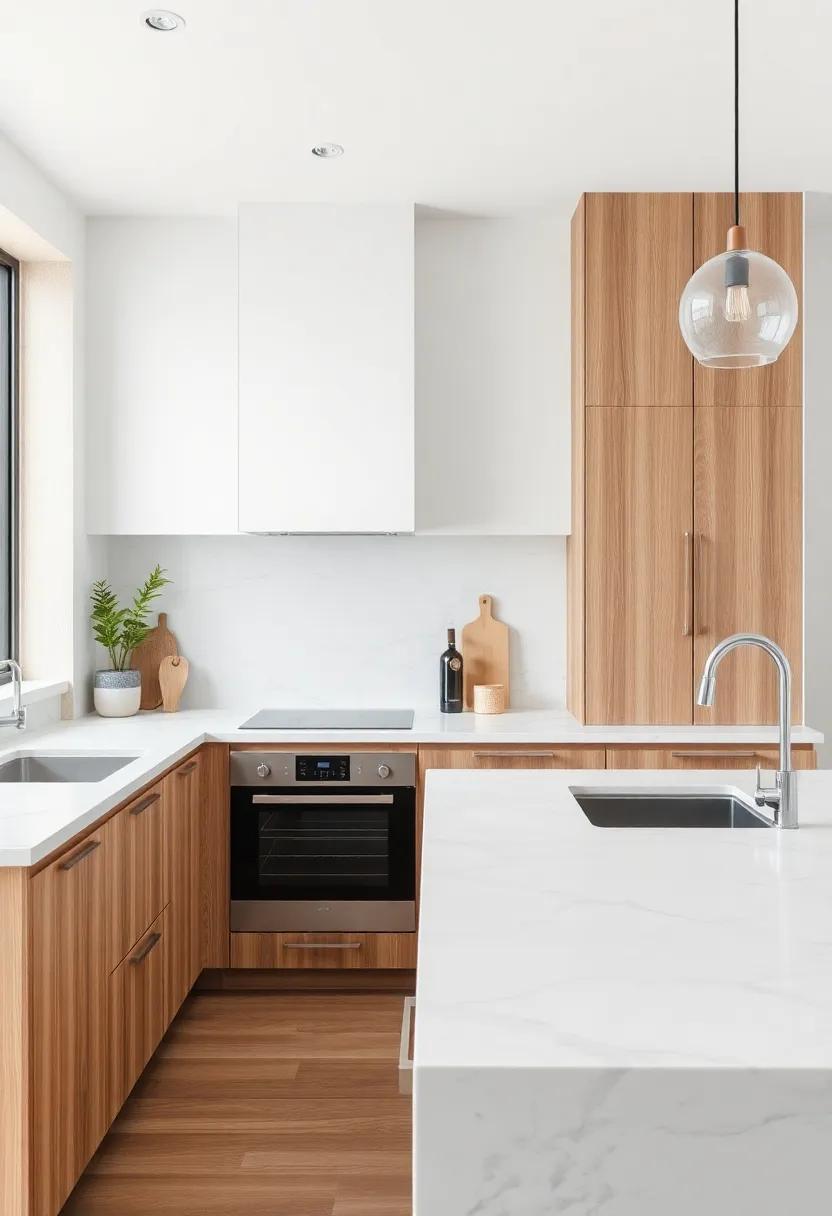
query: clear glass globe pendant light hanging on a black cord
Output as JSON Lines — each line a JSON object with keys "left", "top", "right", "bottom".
{"left": 679, "top": 0, "right": 798, "bottom": 368}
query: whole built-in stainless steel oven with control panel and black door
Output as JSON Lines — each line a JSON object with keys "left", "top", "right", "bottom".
{"left": 231, "top": 751, "right": 416, "bottom": 933}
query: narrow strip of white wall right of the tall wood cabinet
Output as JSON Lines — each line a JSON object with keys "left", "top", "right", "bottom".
{"left": 803, "top": 193, "right": 832, "bottom": 767}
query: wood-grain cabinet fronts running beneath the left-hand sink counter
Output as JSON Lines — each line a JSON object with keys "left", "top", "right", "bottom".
{"left": 27, "top": 755, "right": 206, "bottom": 1216}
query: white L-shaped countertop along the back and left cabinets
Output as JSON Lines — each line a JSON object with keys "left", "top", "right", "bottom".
{"left": 0, "top": 705, "right": 822, "bottom": 866}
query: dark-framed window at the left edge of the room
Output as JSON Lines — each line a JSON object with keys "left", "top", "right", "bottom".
{"left": 0, "top": 249, "right": 19, "bottom": 659}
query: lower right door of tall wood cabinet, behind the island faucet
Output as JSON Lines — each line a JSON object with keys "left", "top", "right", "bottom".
{"left": 693, "top": 406, "right": 803, "bottom": 725}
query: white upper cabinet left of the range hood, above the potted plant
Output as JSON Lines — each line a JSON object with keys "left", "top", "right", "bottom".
{"left": 85, "top": 218, "right": 237, "bottom": 535}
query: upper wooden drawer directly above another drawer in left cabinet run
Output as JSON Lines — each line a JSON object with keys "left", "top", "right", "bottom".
{"left": 108, "top": 783, "right": 165, "bottom": 970}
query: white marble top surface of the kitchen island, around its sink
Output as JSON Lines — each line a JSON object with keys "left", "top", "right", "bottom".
{"left": 415, "top": 770, "right": 832, "bottom": 1074}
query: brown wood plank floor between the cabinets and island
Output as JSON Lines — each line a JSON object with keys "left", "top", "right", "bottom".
{"left": 62, "top": 992, "right": 411, "bottom": 1216}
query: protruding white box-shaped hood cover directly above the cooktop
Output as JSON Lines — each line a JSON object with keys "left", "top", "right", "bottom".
{"left": 240, "top": 203, "right": 415, "bottom": 533}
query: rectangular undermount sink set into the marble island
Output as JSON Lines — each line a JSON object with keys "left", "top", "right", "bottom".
{"left": 569, "top": 788, "right": 771, "bottom": 828}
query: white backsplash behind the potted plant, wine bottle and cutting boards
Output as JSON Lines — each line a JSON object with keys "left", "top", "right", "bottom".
{"left": 107, "top": 536, "right": 566, "bottom": 711}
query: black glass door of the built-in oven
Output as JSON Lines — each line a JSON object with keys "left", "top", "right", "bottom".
{"left": 231, "top": 787, "right": 416, "bottom": 901}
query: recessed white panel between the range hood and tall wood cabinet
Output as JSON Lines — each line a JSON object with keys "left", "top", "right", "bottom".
{"left": 416, "top": 209, "right": 574, "bottom": 535}
